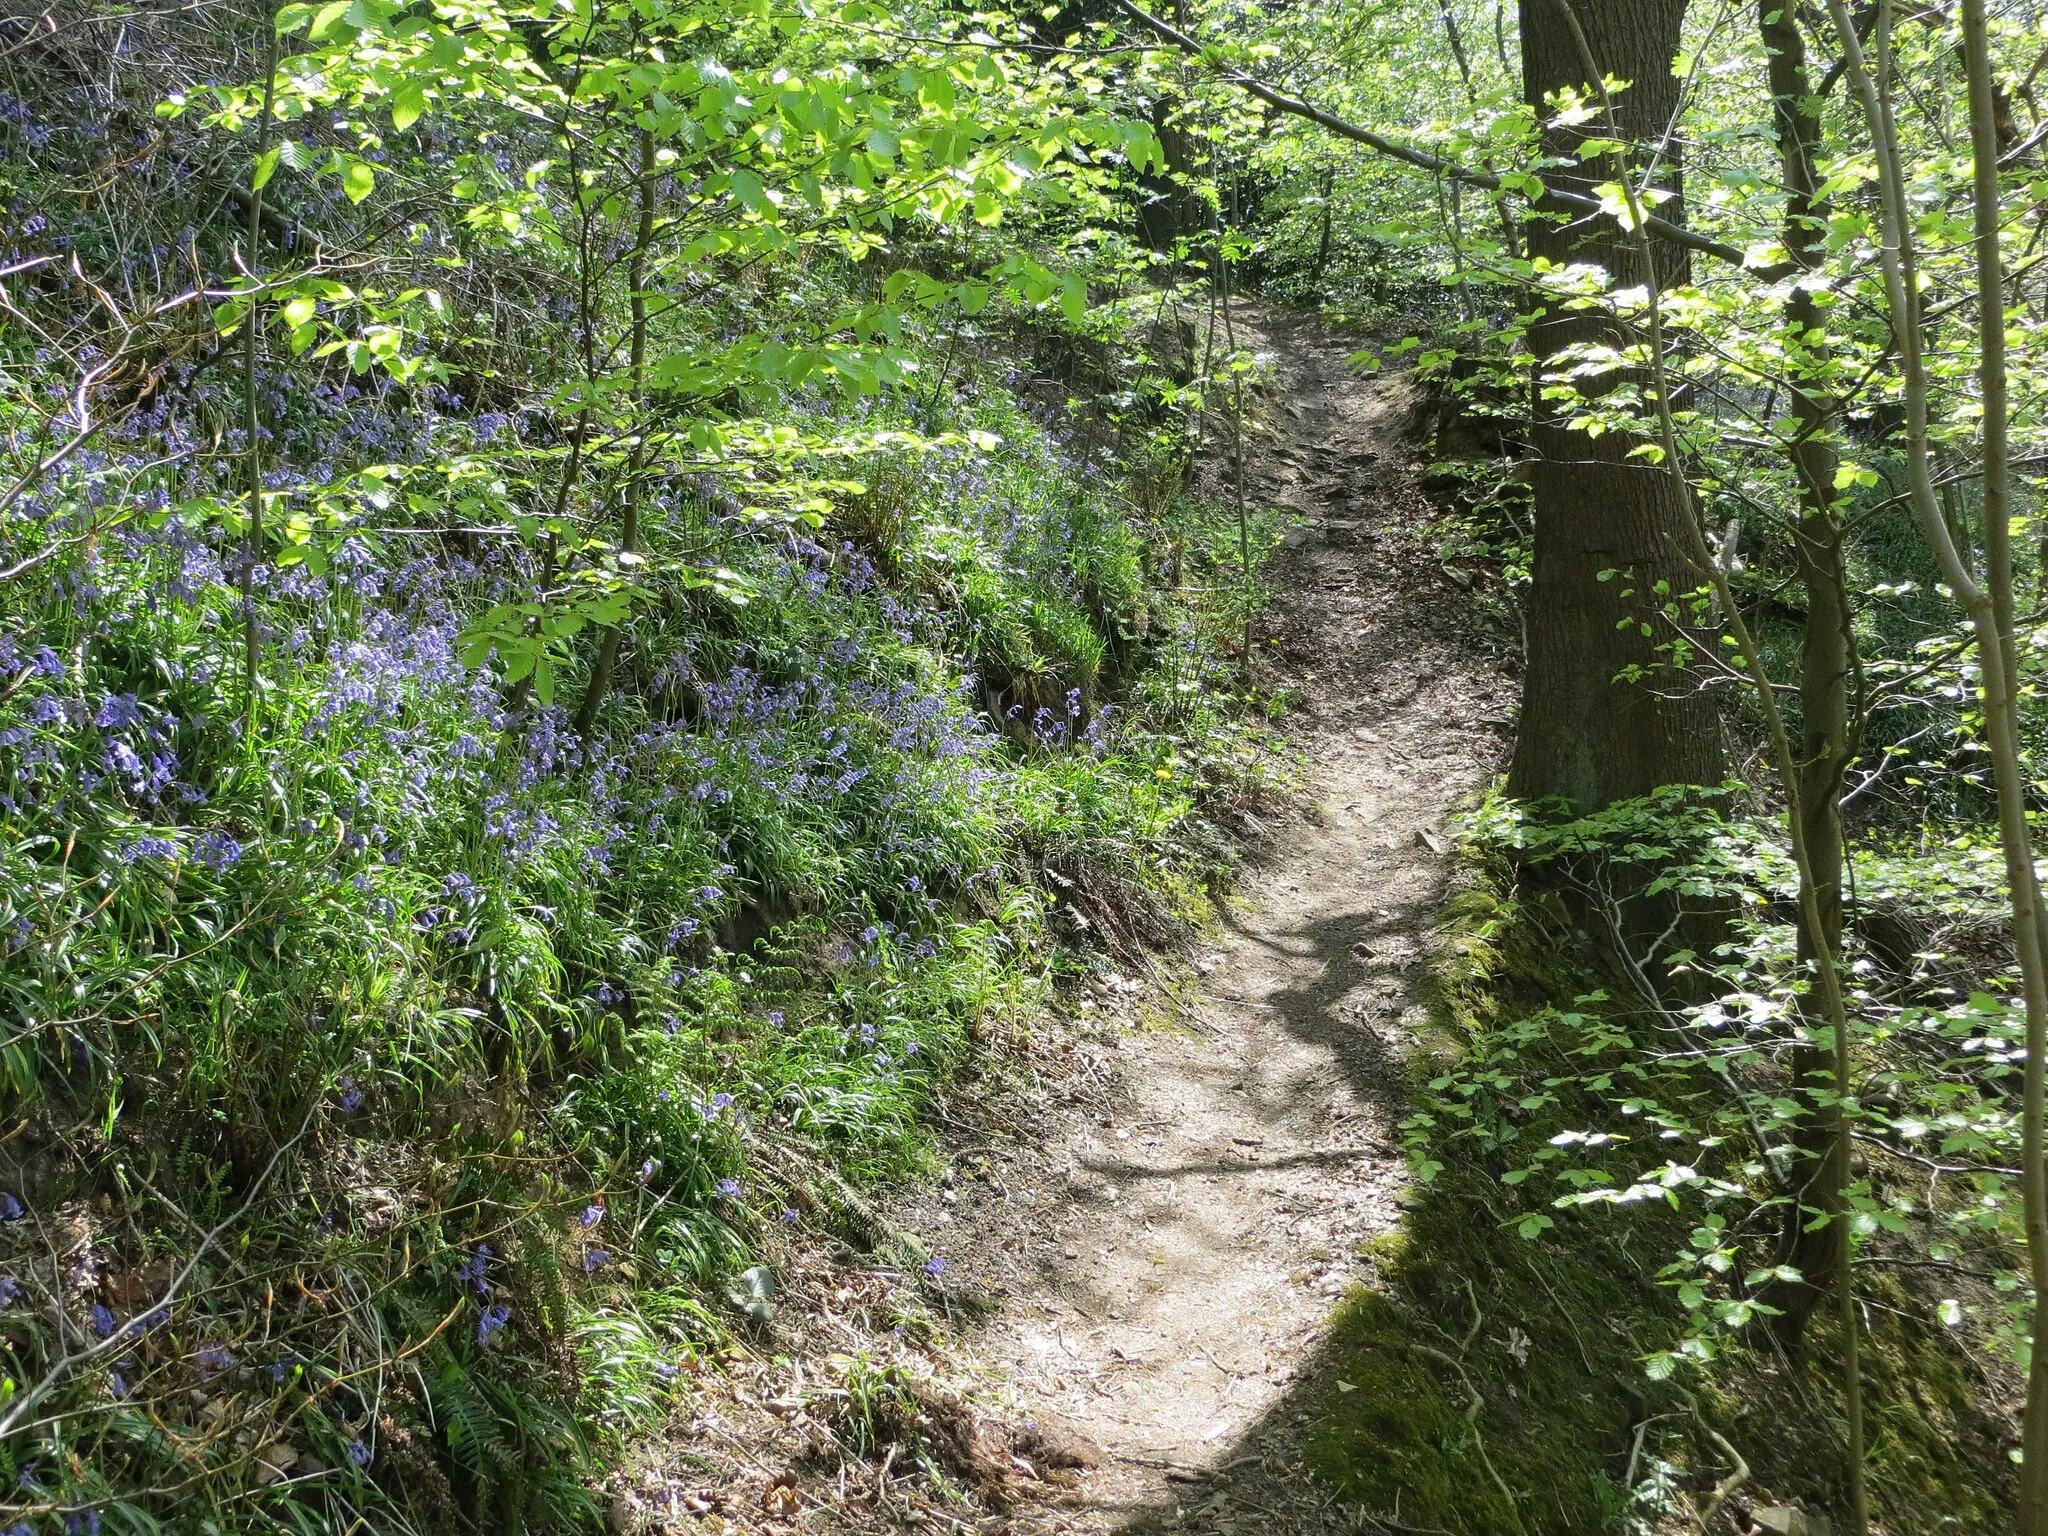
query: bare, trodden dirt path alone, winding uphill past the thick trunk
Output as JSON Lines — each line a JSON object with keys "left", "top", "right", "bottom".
{"left": 920, "top": 303, "right": 1511, "bottom": 1536}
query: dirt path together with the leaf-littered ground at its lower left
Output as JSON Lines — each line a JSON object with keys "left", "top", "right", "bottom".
{"left": 626, "top": 301, "right": 1513, "bottom": 1536}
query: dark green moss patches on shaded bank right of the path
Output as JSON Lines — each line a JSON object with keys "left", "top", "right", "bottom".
{"left": 1307, "top": 856, "right": 2011, "bottom": 1536}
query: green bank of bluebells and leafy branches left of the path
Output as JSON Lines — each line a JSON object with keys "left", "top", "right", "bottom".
{"left": 0, "top": 2, "right": 1276, "bottom": 1530}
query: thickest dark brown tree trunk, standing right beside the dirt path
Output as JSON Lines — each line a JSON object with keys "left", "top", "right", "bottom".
{"left": 1509, "top": 0, "right": 1724, "bottom": 811}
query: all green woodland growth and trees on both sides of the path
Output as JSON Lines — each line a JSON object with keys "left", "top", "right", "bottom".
{"left": 12, "top": 0, "right": 2048, "bottom": 1536}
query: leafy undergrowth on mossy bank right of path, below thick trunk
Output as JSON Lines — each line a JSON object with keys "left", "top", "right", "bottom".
{"left": 1311, "top": 803, "right": 2013, "bottom": 1534}
